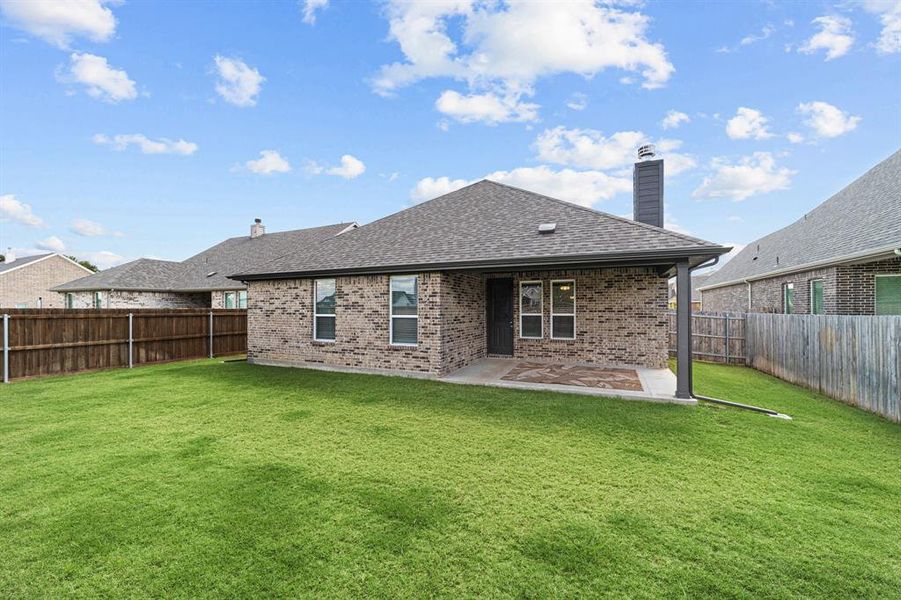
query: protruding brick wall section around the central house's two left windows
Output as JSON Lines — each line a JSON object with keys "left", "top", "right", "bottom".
{"left": 247, "top": 273, "right": 442, "bottom": 375}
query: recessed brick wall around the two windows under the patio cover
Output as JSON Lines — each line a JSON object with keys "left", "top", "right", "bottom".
{"left": 491, "top": 267, "right": 668, "bottom": 368}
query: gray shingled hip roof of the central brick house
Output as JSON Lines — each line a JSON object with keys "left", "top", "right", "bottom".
{"left": 234, "top": 180, "right": 728, "bottom": 279}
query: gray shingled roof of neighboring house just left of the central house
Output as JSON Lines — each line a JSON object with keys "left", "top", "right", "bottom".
{"left": 53, "top": 223, "right": 353, "bottom": 292}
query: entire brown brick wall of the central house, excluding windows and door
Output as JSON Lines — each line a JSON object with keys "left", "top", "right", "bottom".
{"left": 248, "top": 269, "right": 667, "bottom": 375}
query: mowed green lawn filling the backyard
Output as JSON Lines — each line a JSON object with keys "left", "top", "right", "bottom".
{"left": 0, "top": 361, "right": 901, "bottom": 598}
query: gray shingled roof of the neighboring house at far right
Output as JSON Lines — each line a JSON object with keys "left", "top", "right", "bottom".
{"left": 704, "top": 150, "right": 901, "bottom": 288}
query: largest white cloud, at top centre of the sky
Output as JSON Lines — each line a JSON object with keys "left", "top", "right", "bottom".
{"left": 372, "top": 0, "right": 674, "bottom": 122}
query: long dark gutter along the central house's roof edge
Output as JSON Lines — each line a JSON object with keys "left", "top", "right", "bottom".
{"left": 228, "top": 246, "right": 729, "bottom": 281}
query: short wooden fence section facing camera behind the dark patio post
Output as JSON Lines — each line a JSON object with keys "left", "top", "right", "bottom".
{"left": 667, "top": 312, "right": 746, "bottom": 365}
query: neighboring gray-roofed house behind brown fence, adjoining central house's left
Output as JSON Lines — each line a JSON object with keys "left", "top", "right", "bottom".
{"left": 54, "top": 219, "right": 356, "bottom": 308}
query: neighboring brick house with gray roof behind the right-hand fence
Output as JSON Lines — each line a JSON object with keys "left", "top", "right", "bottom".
{"left": 701, "top": 151, "right": 901, "bottom": 315}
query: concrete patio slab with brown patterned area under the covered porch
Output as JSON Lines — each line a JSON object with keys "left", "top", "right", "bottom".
{"left": 441, "top": 358, "right": 684, "bottom": 404}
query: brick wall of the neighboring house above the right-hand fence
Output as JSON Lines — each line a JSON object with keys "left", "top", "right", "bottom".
{"left": 703, "top": 258, "right": 901, "bottom": 315}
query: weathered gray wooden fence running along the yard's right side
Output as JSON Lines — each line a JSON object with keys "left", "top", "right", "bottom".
{"left": 747, "top": 314, "right": 901, "bottom": 422}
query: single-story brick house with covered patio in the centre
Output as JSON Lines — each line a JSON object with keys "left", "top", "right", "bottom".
{"left": 233, "top": 166, "right": 729, "bottom": 397}
